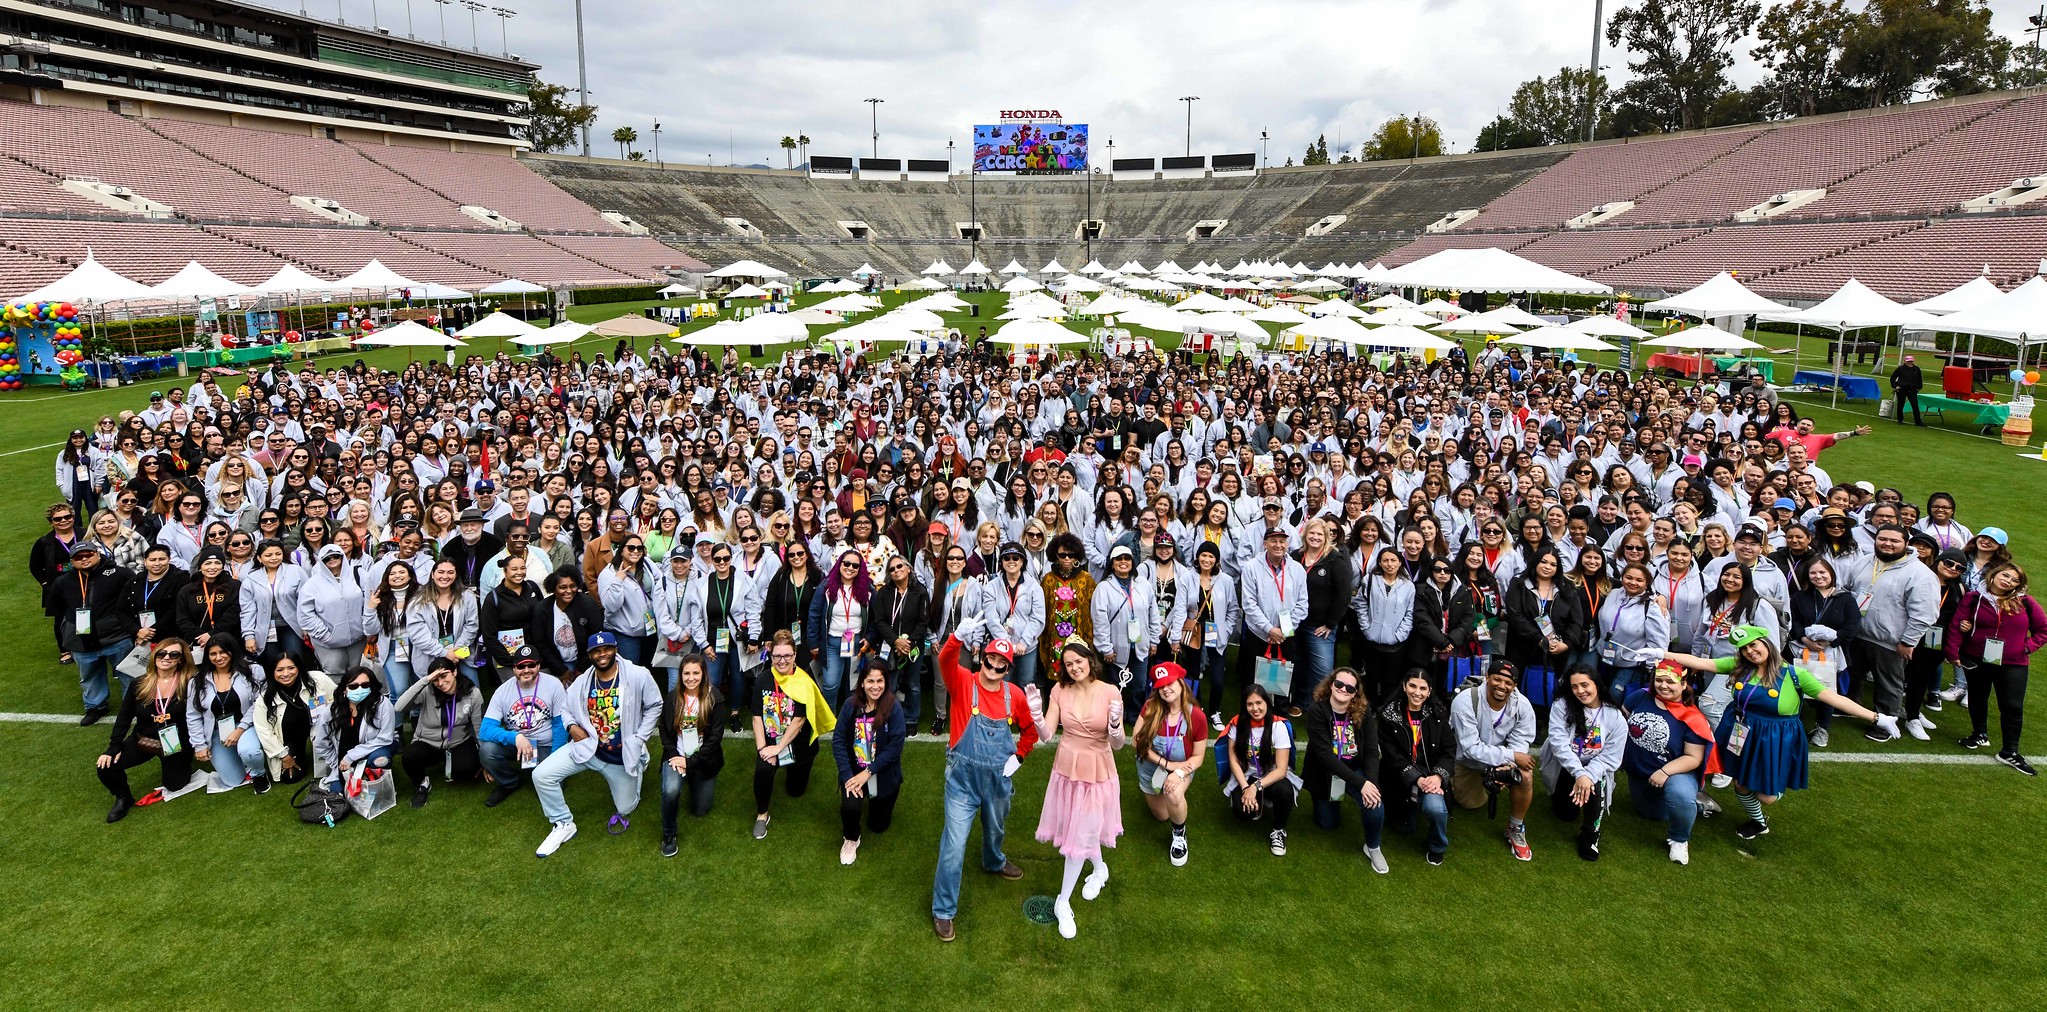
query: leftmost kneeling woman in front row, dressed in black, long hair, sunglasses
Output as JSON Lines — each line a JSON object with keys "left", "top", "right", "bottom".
{"left": 96, "top": 637, "right": 197, "bottom": 821}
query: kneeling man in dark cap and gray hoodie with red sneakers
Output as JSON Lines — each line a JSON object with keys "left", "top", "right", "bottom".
{"left": 1449, "top": 658, "right": 1535, "bottom": 860}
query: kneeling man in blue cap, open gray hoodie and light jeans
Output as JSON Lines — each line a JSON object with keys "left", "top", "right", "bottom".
{"left": 532, "top": 631, "right": 661, "bottom": 858}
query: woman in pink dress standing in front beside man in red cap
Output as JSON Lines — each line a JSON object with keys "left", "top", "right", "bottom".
{"left": 1024, "top": 643, "right": 1124, "bottom": 938}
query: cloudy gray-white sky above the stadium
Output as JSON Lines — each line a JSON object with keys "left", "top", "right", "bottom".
{"left": 280, "top": 0, "right": 2037, "bottom": 166}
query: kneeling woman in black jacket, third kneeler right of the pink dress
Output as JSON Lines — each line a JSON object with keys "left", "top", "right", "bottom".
{"left": 1302, "top": 668, "right": 1388, "bottom": 875}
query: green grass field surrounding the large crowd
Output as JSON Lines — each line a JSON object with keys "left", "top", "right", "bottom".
{"left": 0, "top": 288, "right": 2047, "bottom": 1010}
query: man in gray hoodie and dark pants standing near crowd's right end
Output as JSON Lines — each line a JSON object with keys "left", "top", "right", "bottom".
{"left": 1855, "top": 524, "right": 1941, "bottom": 742}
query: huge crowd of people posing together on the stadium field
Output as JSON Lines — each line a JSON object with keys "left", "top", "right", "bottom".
{"left": 31, "top": 329, "right": 2047, "bottom": 940}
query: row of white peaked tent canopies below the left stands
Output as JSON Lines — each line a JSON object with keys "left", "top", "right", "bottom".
{"left": 14, "top": 250, "right": 569, "bottom": 305}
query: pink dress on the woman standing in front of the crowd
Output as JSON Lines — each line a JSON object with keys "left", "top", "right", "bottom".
{"left": 1038, "top": 686, "right": 1124, "bottom": 858}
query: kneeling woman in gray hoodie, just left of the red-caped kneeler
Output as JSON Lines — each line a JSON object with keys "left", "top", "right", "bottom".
{"left": 1541, "top": 664, "right": 1627, "bottom": 860}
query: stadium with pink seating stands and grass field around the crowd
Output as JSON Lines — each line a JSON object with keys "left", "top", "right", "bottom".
{"left": 0, "top": 0, "right": 2047, "bottom": 1008}
